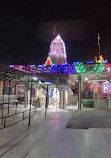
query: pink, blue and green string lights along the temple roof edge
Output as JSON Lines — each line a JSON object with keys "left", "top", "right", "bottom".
{"left": 9, "top": 62, "right": 105, "bottom": 75}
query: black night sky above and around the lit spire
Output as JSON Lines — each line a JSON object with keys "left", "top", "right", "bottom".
{"left": 0, "top": 0, "right": 111, "bottom": 65}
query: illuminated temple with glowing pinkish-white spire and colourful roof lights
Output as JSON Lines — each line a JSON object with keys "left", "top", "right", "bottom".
{"left": 0, "top": 32, "right": 111, "bottom": 113}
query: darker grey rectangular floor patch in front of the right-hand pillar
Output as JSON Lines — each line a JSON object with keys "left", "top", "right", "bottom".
{"left": 67, "top": 108, "right": 111, "bottom": 129}
